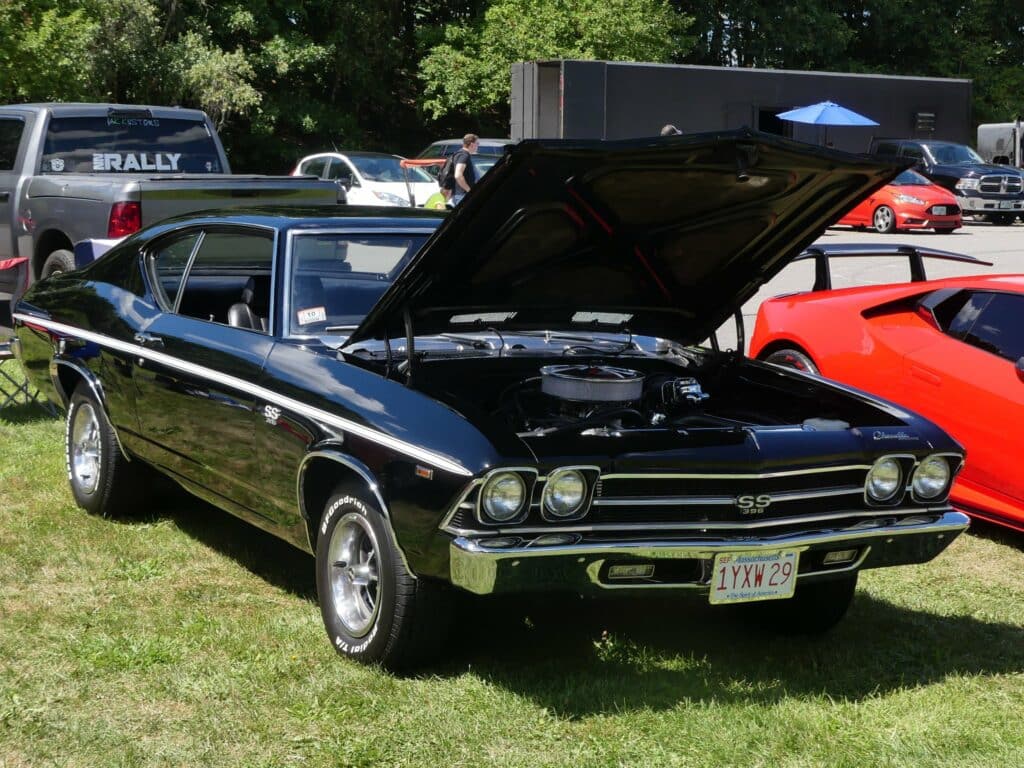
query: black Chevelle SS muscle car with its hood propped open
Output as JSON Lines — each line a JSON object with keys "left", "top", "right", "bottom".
{"left": 15, "top": 131, "right": 968, "bottom": 668}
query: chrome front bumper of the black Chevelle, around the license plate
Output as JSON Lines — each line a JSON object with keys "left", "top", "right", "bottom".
{"left": 450, "top": 508, "right": 970, "bottom": 595}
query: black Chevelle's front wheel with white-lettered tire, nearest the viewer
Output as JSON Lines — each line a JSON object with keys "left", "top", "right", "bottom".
{"left": 316, "top": 485, "right": 453, "bottom": 672}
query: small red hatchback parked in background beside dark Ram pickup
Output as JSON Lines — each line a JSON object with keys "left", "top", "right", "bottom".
{"left": 836, "top": 170, "right": 964, "bottom": 233}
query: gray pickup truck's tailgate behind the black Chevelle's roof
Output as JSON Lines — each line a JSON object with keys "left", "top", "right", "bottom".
{"left": 138, "top": 175, "right": 339, "bottom": 226}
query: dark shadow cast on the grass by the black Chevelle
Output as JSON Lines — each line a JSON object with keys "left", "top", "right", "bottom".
{"left": 114, "top": 493, "right": 1024, "bottom": 718}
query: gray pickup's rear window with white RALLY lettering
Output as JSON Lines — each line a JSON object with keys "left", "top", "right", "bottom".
{"left": 40, "top": 115, "right": 223, "bottom": 173}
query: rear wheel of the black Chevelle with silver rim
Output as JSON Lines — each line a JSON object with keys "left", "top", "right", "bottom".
{"left": 65, "top": 382, "right": 141, "bottom": 517}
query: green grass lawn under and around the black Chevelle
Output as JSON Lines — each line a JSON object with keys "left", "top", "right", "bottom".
{"left": 0, "top": 407, "right": 1024, "bottom": 768}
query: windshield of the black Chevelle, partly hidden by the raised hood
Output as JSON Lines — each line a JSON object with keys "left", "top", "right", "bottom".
{"left": 288, "top": 232, "right": 428, "bottom": 336}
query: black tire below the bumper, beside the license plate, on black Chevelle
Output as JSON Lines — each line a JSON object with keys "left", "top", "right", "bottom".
{"left": 742, "top": 573, "right": 857, "bottom": 635}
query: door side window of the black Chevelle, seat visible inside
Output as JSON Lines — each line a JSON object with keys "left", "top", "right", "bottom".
{"left": 178, "top": 230, "right": 273, "bottom": 330}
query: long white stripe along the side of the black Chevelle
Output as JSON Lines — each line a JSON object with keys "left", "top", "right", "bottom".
{"left": 14, "top": 312, "right": 473, "bottom": 477}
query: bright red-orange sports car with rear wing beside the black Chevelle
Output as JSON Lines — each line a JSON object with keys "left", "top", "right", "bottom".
{"left": 750, "top": 246, "right": 1024, "bottom": 531}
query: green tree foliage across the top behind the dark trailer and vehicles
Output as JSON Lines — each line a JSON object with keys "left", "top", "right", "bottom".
{"left": 0, "top": 0, "right": 1024, "bottom": 171}
